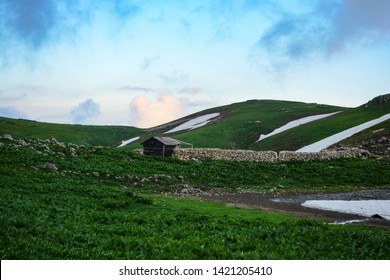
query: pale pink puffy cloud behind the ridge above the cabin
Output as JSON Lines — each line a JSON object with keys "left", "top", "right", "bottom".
{"left": 130, "top": 94, "right": 185, "bottom": 127}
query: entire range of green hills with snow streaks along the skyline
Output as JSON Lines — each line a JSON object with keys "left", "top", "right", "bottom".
{"left": 0, "top": 94, "right": 390, "bottom": 151}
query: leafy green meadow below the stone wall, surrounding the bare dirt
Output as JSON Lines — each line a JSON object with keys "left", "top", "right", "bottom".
{"left": 0, "top": 139, "right": 390, "bottom": 259}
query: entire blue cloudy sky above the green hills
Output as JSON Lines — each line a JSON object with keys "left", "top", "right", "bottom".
{"left": 0, "top": 0, "right": 390, "bottom": 128}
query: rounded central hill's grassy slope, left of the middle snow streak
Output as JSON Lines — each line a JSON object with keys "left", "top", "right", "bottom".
{"left": 126, "top": 100, "right": 345, "bottom": 149}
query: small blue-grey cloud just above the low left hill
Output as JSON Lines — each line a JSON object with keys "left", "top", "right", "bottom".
{"left": 70, "top": 99, "right": 100, "bottom": 124}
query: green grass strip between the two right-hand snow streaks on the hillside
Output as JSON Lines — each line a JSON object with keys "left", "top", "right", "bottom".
{"left": 252, "top": 96, "right": 390, "bottom": 151}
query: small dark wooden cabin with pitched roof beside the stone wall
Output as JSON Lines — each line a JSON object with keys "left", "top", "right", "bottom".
{"left": 141, "top": 136, "right": 181, "bottom": 157}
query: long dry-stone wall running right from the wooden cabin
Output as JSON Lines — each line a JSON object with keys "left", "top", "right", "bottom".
{"left": 172, "top": 148, "right": 369, "bottom": 163}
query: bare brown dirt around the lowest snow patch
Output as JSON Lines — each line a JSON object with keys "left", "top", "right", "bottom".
{"left": 196, "top": 190, "right": 390, "bottom": 229}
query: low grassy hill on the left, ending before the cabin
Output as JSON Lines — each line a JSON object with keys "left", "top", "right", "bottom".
{"left": 0, "top": 117, "right": 142, "bottom": 146}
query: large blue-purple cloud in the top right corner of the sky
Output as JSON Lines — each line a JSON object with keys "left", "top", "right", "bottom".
{"left": 257, "top": 0, "right": 390, "bottom": 67}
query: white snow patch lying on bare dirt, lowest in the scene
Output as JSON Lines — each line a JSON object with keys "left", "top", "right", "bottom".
{"left": 302, "top": 200, "right": 390, "bottom": 220}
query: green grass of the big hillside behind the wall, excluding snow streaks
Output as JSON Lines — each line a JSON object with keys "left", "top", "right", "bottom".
{"left": 125, "top": 95, "right": 390, "bottom": 151}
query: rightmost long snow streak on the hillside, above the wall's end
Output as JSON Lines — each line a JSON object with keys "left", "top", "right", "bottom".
{"left": 297, "top": 114, "right": 390, "bottom": 152}
